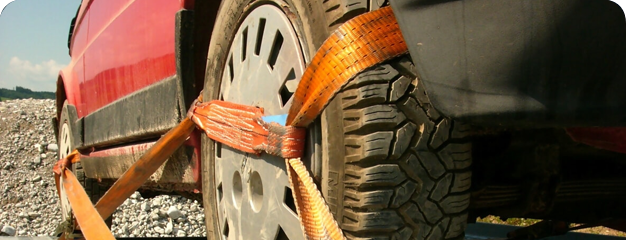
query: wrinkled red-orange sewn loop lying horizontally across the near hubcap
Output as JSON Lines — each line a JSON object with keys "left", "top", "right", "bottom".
{"left": 188, "top": 100, "right": 306, "bottom": 158}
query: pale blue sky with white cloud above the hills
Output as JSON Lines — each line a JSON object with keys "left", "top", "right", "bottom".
{"left": 0, "top": 0, "right": 80, "bottom": 92}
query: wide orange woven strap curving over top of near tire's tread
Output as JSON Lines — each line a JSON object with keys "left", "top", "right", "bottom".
{"left": 287, "top": 7, "right": 407, "bottom": 127}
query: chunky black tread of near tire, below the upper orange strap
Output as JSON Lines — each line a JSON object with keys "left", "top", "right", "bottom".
{"left": 322, "top": 57, "right": 472, "bottom": 239}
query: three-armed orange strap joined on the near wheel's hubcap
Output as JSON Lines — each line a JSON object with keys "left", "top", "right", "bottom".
{"left": 189, "top": 7, "right": 407, "bottom": 240}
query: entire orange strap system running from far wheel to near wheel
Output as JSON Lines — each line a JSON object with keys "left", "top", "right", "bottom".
{"left": 55, "top": 7, "right": 407, "bottom": 240}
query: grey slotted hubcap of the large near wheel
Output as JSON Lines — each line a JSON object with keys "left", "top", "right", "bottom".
{"left": 215, "top": 5, "right": 304, "bottom": 239}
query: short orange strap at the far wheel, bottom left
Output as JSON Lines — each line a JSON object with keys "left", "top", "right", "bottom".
{"left": 53, "top": 150, "right": 115, "bottom": 240}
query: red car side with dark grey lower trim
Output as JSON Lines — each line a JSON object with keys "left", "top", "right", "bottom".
{"left": 57, "top": 0, "right": 207, "bottom": 190}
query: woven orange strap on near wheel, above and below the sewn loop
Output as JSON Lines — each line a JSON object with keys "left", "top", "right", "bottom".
{"left": 286, "top": 7, "right": 407, "bottom": 240}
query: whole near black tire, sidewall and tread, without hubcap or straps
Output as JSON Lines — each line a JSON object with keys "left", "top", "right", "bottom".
{"left": 202, "top": 0, "right": 471, "bottom": 239}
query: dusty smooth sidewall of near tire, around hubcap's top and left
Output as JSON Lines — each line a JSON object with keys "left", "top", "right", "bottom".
{"left": 202, "top": 0, "right": 329, "bottom": 239}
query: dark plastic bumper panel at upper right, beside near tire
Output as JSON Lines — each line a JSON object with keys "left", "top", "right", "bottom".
{"left": 390, "top": 0, "right": 626, "bottom": 128}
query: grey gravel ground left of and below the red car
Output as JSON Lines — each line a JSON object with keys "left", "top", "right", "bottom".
{"left": 0, "top": 99, "right": 206, "bottom": 237}
